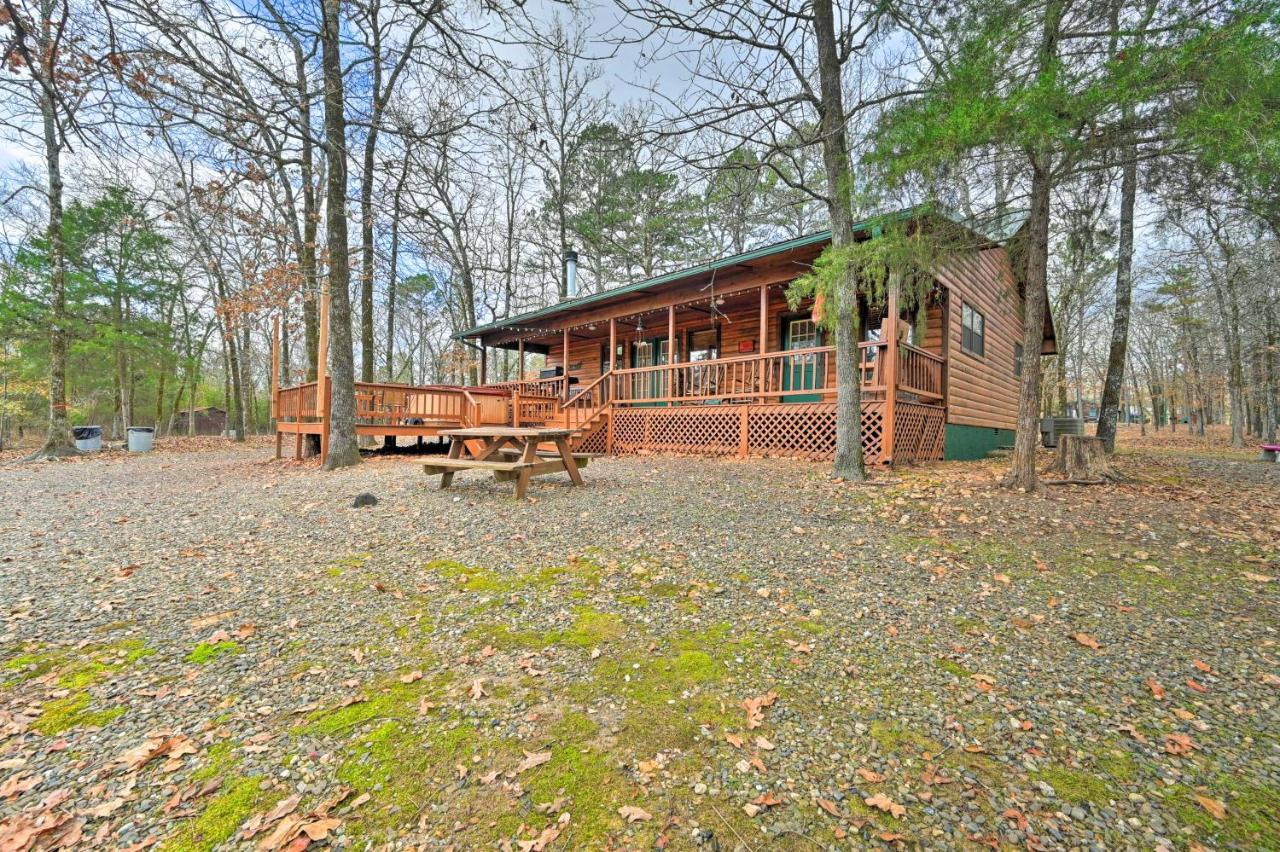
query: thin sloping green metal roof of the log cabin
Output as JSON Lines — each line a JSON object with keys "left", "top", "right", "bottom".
{"left": 453, "top": 206, "right": 1025, "bottom": 340}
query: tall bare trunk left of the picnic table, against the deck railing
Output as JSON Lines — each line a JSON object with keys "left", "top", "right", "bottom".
{"left": 321, "top": 0, "right": 360, "bottom": 471}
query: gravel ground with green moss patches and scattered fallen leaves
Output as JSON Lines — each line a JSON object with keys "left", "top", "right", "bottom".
{"left": 0, "top": 441, "right": 1280, "bottom": 851}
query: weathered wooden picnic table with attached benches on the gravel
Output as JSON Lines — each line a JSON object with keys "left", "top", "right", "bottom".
{"left": 422, "top": 426, "right": 590, "bottom": 500}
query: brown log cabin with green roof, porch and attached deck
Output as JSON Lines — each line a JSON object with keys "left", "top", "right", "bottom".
{"left": 273, "top": 209, "right": 1056, "bottom": 464}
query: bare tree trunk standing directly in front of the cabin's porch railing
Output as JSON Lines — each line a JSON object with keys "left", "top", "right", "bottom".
{"left": 814, "top": 0, "right": 865, "bottom": 482}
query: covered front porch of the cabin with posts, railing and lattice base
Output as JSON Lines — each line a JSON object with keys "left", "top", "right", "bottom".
{"left": 477, "top": 257, "right": 946, "bottom": 464}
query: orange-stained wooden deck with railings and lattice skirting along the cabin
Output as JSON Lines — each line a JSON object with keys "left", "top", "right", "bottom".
{"left": 271, "top": 289, "right": 947, "bottom": 464}
